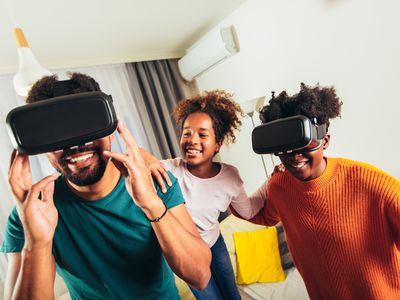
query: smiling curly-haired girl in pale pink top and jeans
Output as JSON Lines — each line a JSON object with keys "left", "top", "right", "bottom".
{"left": 142, "top": 90, "right": 263, "bottom": 300}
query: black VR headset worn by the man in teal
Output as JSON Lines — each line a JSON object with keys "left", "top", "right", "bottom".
{"left": 6, "top": 80, "right": 117, "bottom": 155}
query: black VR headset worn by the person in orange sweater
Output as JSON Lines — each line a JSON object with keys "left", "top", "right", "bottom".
{"left": 251, "top": 115, "right": 326, "bottom": 155}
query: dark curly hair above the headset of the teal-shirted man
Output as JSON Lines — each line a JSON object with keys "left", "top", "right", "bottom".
{"left": 25, "top": 72, "right": 100, "bottom": 103}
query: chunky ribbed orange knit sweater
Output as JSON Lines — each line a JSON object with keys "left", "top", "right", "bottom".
{"left": 251, "top": 158, "right": 400, "bottom": 300}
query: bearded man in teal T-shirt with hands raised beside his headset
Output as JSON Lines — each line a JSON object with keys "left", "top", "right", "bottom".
{"left": 1, "top": 73, "right": 211, "bottom": 300}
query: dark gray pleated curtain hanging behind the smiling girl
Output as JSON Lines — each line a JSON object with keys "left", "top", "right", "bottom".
{"left": 126, "top": 59, "right": 190, "bottom": 159}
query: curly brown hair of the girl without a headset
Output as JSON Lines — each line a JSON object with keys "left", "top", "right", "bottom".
{"left": 172, "top": 90, "right": 244, "bottom": 144}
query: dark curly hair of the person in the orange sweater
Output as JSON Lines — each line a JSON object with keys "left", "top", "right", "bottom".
{"left": 260, "top": 83, "right": 343, "bottom": 129}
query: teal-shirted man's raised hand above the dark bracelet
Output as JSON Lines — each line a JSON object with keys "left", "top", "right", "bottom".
{"left": 104, "top": 121, "right": 164, "bottom": 213}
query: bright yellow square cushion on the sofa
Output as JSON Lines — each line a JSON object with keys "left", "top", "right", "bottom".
{"left": 233, "top": 227, "right": 285, "bottom": 284}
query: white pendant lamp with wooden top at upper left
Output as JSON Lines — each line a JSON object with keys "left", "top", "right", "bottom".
{"left": 13, "top": 28, "right": 52, "bottom": 97}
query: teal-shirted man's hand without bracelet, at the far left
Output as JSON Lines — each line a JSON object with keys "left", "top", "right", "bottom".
{"left": 9, "top": 153, "right": 59, "bottom": 248}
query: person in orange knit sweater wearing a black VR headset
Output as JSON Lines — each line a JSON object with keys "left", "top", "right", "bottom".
{"left": 234, "top": 84, "right": 400, "bottom": 299}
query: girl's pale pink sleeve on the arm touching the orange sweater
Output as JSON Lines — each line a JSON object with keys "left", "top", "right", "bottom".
{"left": 231, "top": 171, "right": 267, "bottom": 220}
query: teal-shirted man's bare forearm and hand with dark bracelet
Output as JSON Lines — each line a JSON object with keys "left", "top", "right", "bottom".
{"left": 103, "top": 121, "right": 211, "bottom": 289}
